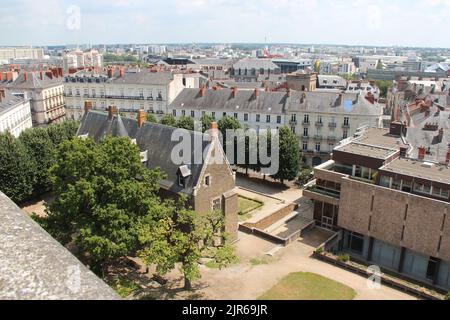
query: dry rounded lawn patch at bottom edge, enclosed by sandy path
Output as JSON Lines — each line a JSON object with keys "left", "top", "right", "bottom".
{"left": 258, "top": 272, "right": 356, "bottom": 300}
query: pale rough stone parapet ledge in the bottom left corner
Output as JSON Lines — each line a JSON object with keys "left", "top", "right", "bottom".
{"left": 0, "top": 192, "right": 120, "bottom": 300}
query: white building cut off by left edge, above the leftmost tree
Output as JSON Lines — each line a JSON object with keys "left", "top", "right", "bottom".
{"left": 0, "top": 89, "right": 33, "bottom": 137}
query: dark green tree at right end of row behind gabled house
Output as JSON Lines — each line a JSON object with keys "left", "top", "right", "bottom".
{"left": 272, "top": 126, "right": 300, "bottom": 183}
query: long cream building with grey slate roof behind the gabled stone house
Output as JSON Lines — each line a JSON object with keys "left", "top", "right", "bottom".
{"left": 168, "top": 87, "right": 383, "bottom": 166}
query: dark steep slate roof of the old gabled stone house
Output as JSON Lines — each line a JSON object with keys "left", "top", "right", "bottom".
{"left": 78, "top": 111, "right": 211, "bottom": 195}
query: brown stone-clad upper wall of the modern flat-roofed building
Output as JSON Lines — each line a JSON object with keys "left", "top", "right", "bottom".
{"left": 338, "top": 178, "right": 450, "bottom": 261}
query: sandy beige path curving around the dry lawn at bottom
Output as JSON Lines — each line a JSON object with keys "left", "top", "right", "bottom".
{"left": 201, "top": 233, "right": 415, "bottom": 300}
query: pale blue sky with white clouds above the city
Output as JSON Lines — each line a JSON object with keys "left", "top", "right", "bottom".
{"left": 0, "top": 0, "right": 450, "bottom": 48}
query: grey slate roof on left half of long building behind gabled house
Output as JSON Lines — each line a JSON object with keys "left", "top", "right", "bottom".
{"left": 170, "top": 89, "right": 288, "bottom": 114}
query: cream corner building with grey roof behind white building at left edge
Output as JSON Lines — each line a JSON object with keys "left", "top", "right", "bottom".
{"left": 0, "top": 68, "right": 66, "bottom": 126}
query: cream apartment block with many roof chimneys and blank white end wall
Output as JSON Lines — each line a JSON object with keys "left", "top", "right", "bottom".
{"left": 64, "top": 68, "right": 184, "bottom": 120}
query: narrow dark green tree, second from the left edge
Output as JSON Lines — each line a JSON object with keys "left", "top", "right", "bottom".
{"left": 19, "top": 128, "right": 55, "bottom": 195}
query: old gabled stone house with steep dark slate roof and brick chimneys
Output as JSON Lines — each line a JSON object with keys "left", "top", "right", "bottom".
{"left": 78, "top": 103, "right": 238, "bottom": 242}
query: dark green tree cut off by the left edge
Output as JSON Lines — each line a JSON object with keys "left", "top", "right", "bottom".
{"left": 0, "top": 132, "right": 36, "bottom": 203}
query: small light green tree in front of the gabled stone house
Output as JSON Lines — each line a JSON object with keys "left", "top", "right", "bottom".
{"left": 138, "top": 201, "right": 236, "bottom": 290}
